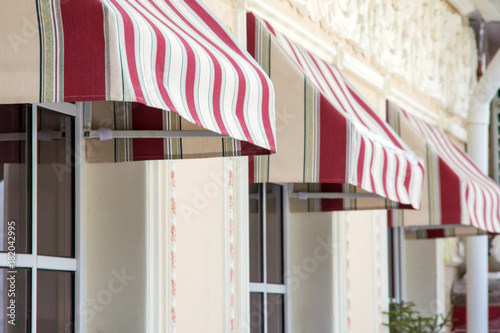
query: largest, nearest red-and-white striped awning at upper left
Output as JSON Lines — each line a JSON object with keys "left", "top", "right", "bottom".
{"left": 0, "top": 0, "right": 276, "bottom": 160}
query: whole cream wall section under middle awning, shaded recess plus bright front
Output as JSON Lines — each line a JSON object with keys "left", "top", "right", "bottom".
{"left": 288, "top": 211, "right": 389, "bottom": 333}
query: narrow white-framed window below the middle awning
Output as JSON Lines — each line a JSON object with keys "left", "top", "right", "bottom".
{"left": 249, "top": 184, "right": 286, "bottom": 333}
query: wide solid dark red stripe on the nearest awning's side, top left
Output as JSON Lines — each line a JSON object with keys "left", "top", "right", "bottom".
{"left": 61, "top": 0, "right": 106, "bottom": 102}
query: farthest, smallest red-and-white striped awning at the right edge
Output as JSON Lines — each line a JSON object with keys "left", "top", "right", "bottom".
{"left": 388, "top": 102, "right": 500, "bottom": 233}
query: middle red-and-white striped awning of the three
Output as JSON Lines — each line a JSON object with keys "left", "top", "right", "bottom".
{"left": 247, "top": 14, "right": 424, "bottom": 210}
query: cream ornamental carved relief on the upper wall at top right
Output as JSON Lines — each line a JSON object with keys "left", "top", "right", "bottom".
{"left": 285, "top": 0, "right": 477, "bottom": 117}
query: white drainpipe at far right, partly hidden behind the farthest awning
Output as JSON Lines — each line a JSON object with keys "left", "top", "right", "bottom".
{"left": 467, "top": 104, "right": 489, "bottom": 333}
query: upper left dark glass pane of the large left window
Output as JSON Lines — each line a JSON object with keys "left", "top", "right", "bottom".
{"left": 0, "top": 104, "right": 31, "bottom": 253}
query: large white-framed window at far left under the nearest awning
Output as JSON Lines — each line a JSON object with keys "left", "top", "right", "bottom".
{"left": 0, "top": 103, "right": 78, "bottom": 333}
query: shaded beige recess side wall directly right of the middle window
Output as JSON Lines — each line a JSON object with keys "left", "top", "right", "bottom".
{"left": 287, "top": 213, "right": 334, "bottom": 333}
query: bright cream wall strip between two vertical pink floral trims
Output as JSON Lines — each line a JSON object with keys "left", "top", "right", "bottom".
{"left": 175, "top": 159, "right": 227, "bottom": 333}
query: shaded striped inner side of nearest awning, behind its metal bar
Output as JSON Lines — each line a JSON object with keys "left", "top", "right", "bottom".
{"left": 86, "top": 102, "right": 269, "bottom": 163}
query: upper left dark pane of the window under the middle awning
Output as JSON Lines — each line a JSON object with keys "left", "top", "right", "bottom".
{"left": 250, "top": 184, "right": 264, "bottom": 282}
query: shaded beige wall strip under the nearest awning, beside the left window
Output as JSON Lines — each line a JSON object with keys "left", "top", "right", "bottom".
{"left": 85, "top": 162, "right": 147, "bottom": 333}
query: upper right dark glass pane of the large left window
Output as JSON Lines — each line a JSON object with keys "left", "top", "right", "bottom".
{"left": 37, "top": 108, "right": 75, "bottom": 257}
